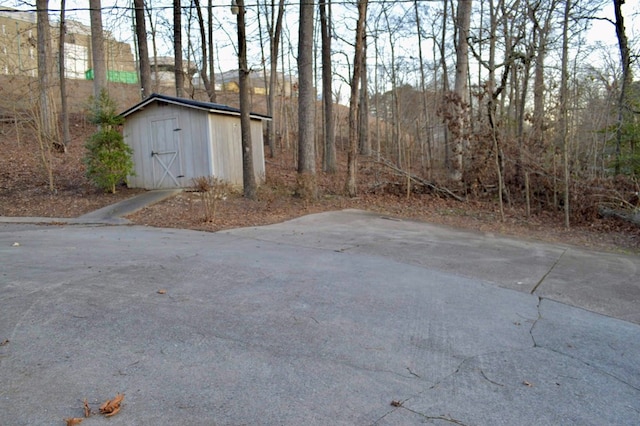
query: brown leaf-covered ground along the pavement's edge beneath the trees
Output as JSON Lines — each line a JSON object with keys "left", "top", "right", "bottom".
{"left": 0, "top": 117, "right": 640, "bottom": 253}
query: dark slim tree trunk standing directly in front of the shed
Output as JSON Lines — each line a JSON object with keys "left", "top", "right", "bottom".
{"left": 236, "top": 0, "right": 257, "bottom": 200}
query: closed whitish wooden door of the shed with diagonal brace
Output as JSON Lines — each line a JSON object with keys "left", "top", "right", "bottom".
{"left": 151, "top": 118, "right": 183, "bottom": 188}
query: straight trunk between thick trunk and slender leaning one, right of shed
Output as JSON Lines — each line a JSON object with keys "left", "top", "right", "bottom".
{"left": 320, "top": 0, "right": 338, "bottom": 173}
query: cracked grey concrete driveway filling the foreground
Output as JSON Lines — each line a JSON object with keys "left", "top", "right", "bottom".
{"left": 0, "top": 211, "right": 640, "bottom": 426}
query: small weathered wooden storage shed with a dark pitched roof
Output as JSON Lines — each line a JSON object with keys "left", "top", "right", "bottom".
{"left": 121, "top": 93, "right": 271, "bottom": 189}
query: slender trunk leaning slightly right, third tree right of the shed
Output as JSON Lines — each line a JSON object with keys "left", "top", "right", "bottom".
{"left": 346, "top": 0, "right": 368, "bottom": 197}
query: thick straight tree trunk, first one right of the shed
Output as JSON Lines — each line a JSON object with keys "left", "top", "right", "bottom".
{"left": 298, "top": 0, "right": 316, "bottom": 197}
